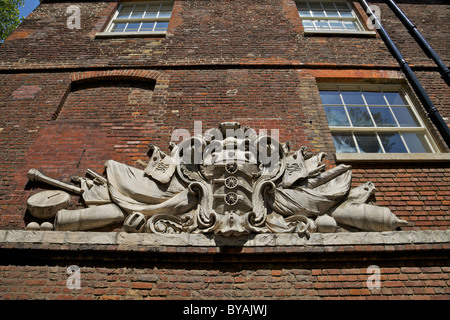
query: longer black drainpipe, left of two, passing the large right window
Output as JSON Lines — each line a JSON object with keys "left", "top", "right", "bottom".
{"left": 360, "top": 0, "right": 450, "bottom": 148}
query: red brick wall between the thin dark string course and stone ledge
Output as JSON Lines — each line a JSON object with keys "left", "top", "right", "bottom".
{"left": 0, "top": 69, "right": 450, "bottom": 229}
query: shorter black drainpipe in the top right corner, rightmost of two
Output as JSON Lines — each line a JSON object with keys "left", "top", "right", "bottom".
{"left": 386, "top": 0, "right": 450, "bottom": 86}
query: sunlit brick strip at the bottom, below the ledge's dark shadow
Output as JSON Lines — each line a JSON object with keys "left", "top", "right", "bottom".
{"left": 0, "top": 264, "right": 450, "bottom": 300}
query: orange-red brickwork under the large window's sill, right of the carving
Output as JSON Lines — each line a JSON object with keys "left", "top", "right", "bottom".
{"left": 353, "top": 164, "right": 450, "bottom": 230}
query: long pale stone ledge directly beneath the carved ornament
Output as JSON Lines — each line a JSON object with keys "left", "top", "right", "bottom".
{"left": 0, "top": 230, "right": 450, "bottom": 251}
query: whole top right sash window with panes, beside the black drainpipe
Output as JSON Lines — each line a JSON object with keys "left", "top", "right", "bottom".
{"left": 296, "top": 0, "right": 375, "bottom": 34}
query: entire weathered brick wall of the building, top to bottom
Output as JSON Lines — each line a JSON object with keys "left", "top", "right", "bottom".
{"left": 0, "top": 0, "right": 450, "bottom": 299}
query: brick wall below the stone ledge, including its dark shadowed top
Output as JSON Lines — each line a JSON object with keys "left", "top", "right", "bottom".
{"left": 0, "top": 244, "right": 450, "bottom": 300}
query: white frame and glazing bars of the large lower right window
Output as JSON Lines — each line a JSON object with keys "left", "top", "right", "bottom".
{"left": 319, "top": 83, "right": 440, "bottom": 159}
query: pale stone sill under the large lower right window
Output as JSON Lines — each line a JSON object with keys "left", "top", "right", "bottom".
{"left": 334, "top": 153, "right": 450, "bottom": 163}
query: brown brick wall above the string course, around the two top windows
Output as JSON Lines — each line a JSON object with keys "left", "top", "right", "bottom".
{"left": 0, "top": 0, "right": 395, "bottom": 69}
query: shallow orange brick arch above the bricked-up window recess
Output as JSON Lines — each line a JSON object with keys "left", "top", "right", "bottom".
{"left": 70, "top": 69, "right": 162, "bottom": 83}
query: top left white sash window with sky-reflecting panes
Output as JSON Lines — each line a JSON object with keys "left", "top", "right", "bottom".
{"left": 97, "top": 1, "right": 173, "bottom": 36}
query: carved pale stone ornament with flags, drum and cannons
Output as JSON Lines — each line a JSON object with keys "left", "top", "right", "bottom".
{"left": 28, "top": 122, "right": 407, "bottom": 236}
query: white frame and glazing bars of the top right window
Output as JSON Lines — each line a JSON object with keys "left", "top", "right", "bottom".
{"left": 295, "top": 0, "right": 376, "bottom": 36}
